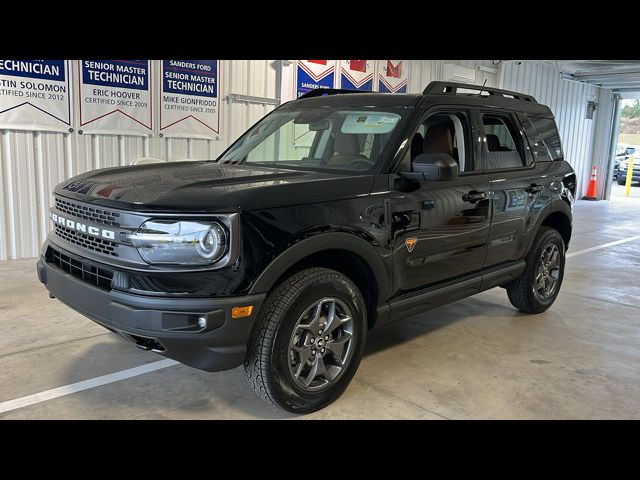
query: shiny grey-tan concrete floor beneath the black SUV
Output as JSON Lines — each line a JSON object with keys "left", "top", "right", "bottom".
{"left": 0, "top": 197, "right": 640, "bottom": 419}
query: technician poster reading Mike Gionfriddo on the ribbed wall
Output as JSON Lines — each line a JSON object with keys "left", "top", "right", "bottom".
{"left": 160, "top": 60, "right": 220, "bottom": 138}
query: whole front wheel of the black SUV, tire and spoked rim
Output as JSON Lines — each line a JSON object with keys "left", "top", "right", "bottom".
{"left": 244, "top": 268, "right": 367, "bottom": 413}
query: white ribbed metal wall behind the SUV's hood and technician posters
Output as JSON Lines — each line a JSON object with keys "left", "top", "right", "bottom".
{"left": 0, "top": 60, "right": 498, "bottom": 260}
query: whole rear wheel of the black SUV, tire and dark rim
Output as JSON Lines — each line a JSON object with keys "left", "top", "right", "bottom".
{"left": 506, "top": 227, "right": 565, "bottom": 313}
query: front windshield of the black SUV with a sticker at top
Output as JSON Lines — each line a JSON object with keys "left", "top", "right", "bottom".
{"left": 219, "top": 107, "right": 410, "bottom": 173}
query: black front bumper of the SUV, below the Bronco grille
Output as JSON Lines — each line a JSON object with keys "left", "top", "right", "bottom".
{"left": 37, "top": 249, "right": 266, "bottom": 371}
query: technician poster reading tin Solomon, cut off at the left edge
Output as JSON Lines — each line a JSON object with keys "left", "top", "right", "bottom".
{"left": 0, "top": 60, "right": 72, "bottom": 132}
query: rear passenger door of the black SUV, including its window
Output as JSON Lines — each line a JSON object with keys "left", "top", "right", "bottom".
{"left": 476, "top": 111, "right": 551, "bottom": 268}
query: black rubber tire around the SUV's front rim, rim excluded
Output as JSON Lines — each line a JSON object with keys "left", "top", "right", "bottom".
{"left": 244, "top": 268, "right": 367, "bottom": 414}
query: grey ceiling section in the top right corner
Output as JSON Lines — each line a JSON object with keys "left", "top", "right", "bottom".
{"left": 547, "top": 60, "right": 640, "bottom": 96}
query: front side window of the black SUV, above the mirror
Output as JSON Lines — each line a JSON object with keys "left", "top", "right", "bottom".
{"left": 401, "top": 112, "right": 474, "bottom": 173}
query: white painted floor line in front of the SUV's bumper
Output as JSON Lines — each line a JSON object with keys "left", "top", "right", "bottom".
{"left": 0, "top": 359, "right": 178, "bottom": 413}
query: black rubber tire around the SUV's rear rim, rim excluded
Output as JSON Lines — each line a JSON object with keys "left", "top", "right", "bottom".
{"left": 505, "top": 226, "right": 565, "bottom": 313}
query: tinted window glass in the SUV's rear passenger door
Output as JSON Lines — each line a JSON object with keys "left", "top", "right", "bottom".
{"left": 482, "top": 114, "right": 524, "bottom": 170}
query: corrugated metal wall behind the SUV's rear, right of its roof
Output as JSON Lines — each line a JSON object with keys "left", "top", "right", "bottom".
{"left": 498, "top": 61, "right": 611, "bottom": 198}
